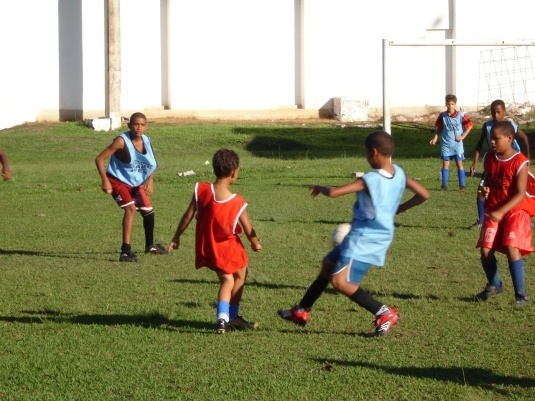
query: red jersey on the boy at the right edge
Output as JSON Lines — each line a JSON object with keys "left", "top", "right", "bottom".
{"left": 483, "top": 151, "right": 529, "bottom": 213}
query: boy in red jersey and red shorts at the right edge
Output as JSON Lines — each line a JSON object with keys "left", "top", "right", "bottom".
{"left": 475, "top": 121, "right": 534, "bottom": 306}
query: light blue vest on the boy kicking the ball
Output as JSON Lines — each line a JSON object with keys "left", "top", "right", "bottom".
{"left": 340, "top": 164, "right": 407, "bottom": 266}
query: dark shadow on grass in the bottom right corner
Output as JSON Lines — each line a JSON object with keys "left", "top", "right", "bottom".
{"left": 313, "top": 358, "right": 535, "bottom": 394}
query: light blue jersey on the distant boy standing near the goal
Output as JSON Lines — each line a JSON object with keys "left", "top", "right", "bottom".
{"left": 435, "top": 111, "right": 472, "bottom": 157}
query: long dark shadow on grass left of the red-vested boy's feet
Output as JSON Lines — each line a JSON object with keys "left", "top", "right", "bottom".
{"left": 0, "top": 310, "right": 214, "bottom": 331}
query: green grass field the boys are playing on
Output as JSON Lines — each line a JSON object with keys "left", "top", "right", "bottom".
{"left": 0, "top": 122, "right": 535, "bottom": 401}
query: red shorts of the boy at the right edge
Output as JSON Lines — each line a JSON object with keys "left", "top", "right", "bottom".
{"left": 476, "top": 209, "right": 533, "bottom": 255}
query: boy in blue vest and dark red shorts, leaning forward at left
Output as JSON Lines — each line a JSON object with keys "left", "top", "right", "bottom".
{"left": 95, "top": 113, "right": 169, "bottom": 262}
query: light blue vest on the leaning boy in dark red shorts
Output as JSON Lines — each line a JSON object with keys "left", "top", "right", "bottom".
{"left": 107, "top": 132, "right": 157, "bottom": 187}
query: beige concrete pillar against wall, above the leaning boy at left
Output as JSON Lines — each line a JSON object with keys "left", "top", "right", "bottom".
{"left": 106, "top": 0, "right": 121, "bottom": 129}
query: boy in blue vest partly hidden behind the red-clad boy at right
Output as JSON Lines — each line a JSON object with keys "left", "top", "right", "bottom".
{"left": 470, "top": 99, "right": 529, "bottom": 230}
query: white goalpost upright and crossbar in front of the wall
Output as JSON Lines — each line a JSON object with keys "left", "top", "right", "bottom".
{"left": 383, "top": 39, "right": 535, "bottom": 134}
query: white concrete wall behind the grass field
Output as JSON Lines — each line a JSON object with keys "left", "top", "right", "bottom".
{"left": 0, "top": 0, "right": 535, "bottom": 129}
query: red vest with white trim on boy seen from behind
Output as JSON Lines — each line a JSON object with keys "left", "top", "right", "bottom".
{"left": 195, "top": 182, "right": 248, "bottom": 274}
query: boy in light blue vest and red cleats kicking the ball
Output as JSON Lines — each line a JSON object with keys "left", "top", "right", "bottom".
{"left": 278, "top": 131, "right": 429, "bottom": 336}
